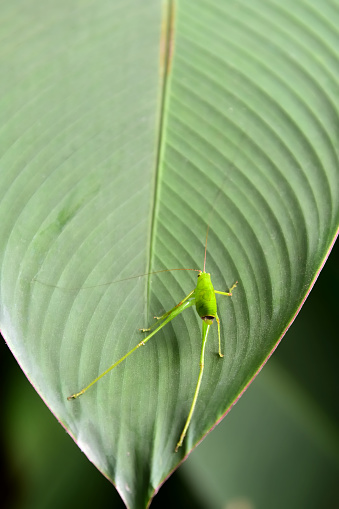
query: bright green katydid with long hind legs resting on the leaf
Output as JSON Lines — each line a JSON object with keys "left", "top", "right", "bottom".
{"left": 67, "top": 227, "right": 237, "bottom": 452}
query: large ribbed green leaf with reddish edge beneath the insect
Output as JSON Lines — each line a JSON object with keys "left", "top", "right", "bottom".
{"left": 0, "top": 0, "right": 339, "bottom": 508}
